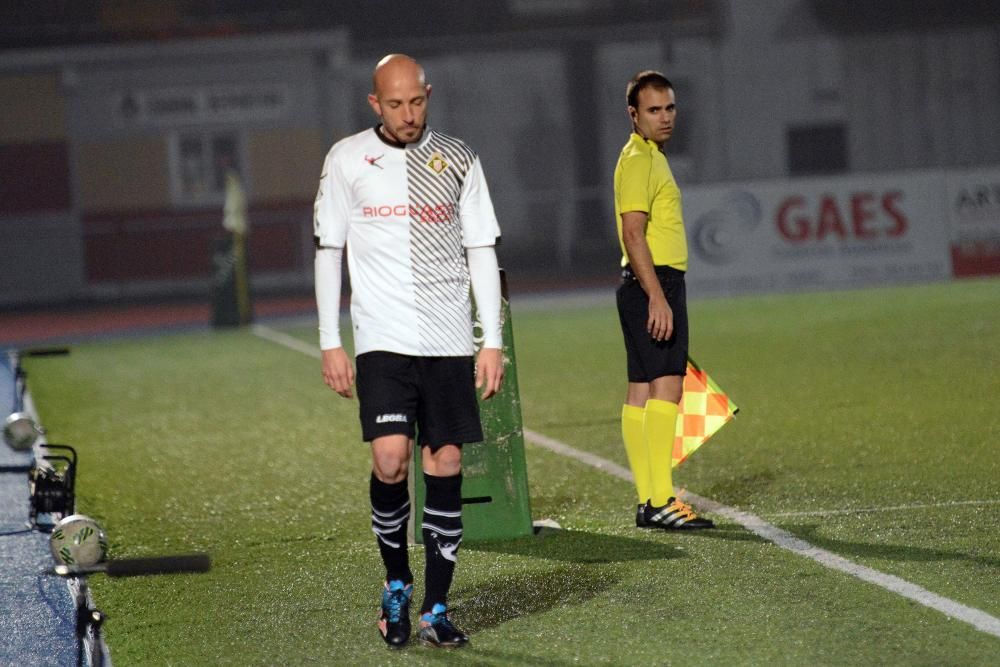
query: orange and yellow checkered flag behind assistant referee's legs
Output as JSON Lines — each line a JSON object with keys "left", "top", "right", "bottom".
{"left": 673, "top": 357, "right": 740, "bottom": 468}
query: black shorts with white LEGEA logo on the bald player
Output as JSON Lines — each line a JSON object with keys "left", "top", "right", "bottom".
{"left": 355, "top": 352, "right": 483, "bottom": 450}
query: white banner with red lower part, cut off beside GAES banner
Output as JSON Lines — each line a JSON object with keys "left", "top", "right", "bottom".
{"left": 946, "top": 168, "right": 1000, "bottom": 276}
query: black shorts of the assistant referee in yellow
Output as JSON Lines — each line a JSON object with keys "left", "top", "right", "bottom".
{"left": 617, "top": 266, "right": 688, "bottom": 382}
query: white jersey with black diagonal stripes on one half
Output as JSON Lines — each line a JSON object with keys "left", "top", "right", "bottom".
{"left": 314, "top": 129, "right": 500, "bottom": 356}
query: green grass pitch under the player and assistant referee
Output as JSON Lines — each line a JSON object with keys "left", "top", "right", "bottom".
{"left": 25, "top": 280, "right": 1000, "bottom": 665}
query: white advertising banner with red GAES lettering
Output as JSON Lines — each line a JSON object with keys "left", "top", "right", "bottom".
{"left": 683, "top": 172, "right": 952, "bottom": 296}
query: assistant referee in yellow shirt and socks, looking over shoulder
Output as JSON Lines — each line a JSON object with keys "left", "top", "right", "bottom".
{"left": 615, "top": 70, "right": 714, "bottom": 530}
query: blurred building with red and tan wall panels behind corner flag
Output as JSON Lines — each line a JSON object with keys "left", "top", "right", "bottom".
{"left": 0, "top": 31, "right": 347, "bottom": 305}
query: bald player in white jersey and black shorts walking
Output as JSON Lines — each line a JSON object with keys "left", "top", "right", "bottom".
{"left": 314, "top": 54, "right": 503, "bottom": 648}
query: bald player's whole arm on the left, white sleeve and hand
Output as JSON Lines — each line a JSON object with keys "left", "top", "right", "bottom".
{"left": 313, "top": 149, "right": 354, "bottom": 398}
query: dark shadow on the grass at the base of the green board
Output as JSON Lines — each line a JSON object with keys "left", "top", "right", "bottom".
{"left": 462, "top": 530, "right": 684, "bottom": 563}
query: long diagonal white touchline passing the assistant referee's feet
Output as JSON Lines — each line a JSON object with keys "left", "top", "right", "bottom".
{"left": 253, "top": 325, "right": 1000, "bottom": 637}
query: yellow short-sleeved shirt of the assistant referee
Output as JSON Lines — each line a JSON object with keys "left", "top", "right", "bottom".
{"left": 615, "top": 132, "right": 687, "bottom": 271}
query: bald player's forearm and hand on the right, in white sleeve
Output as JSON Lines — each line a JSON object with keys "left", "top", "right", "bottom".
{"left": 465, "top": 246, "right": 503, "bottom": 399}
